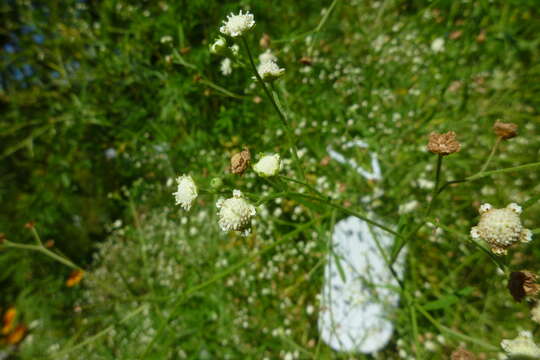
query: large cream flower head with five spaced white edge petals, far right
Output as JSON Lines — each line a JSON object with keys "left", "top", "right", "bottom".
{"left": 471, "top": 203, "right": 532, "bottom": 255}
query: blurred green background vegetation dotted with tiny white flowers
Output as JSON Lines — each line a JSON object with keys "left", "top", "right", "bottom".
{"left": 0, "top": 0, "right": 540, "bottom": 359}
